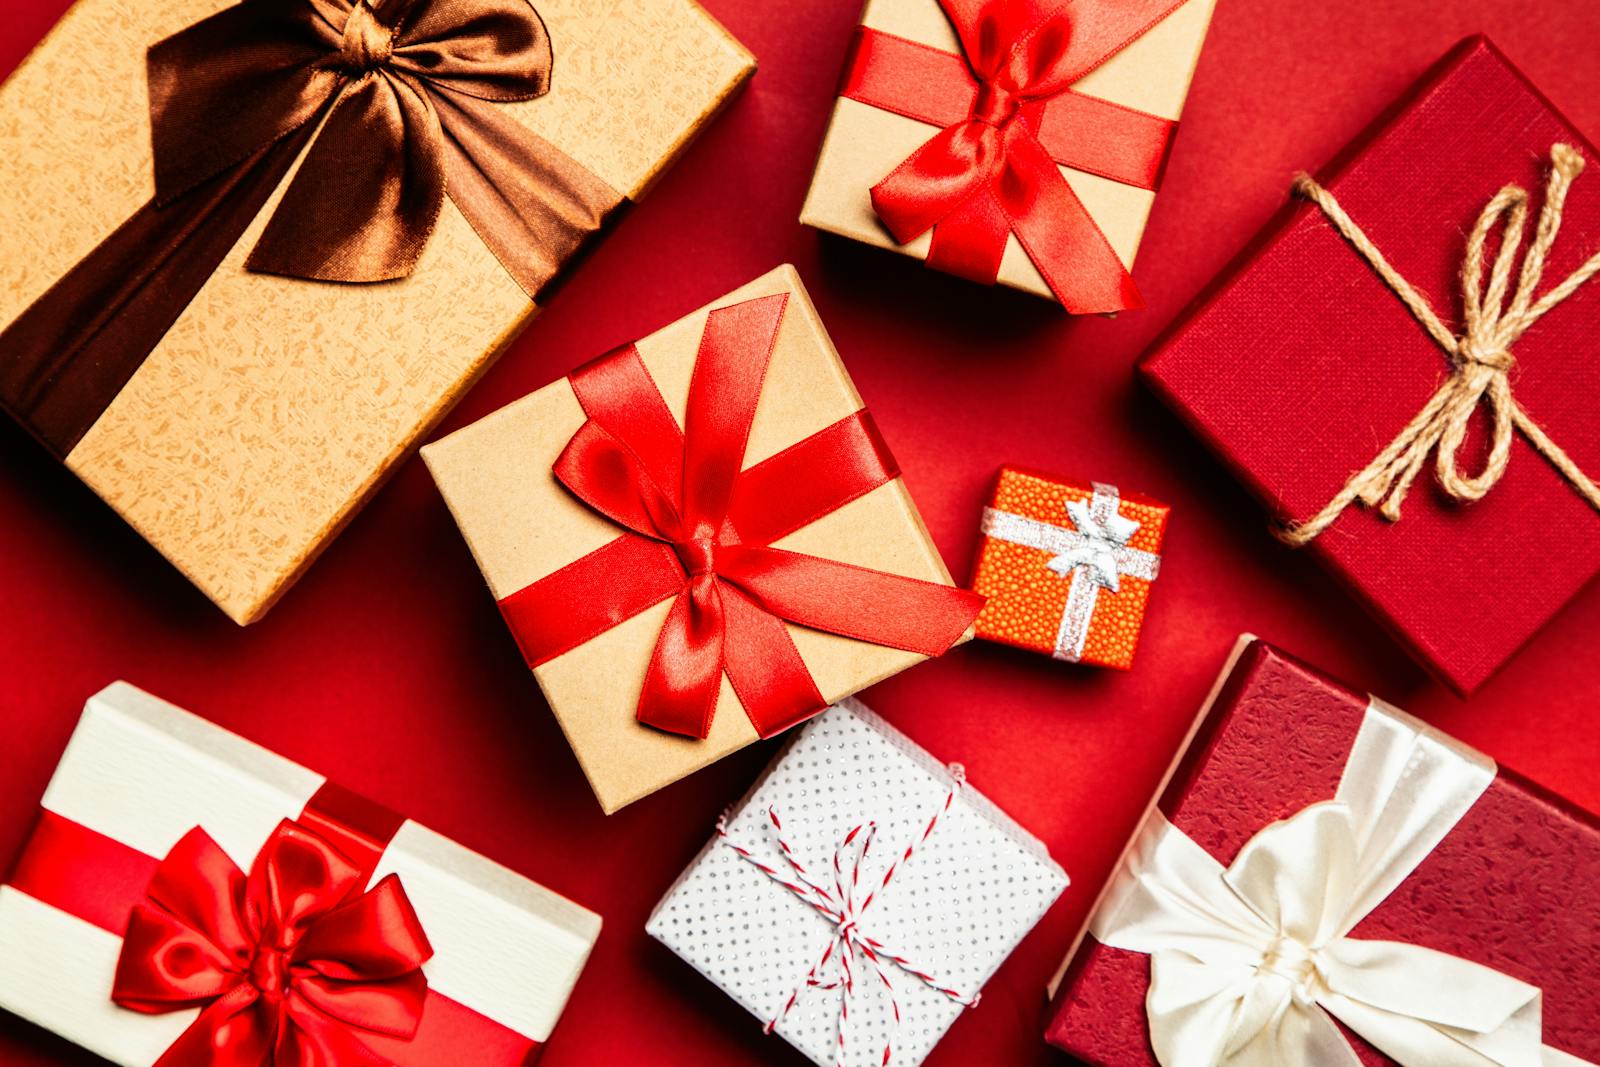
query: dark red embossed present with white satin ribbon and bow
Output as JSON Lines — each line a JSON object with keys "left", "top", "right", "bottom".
{"left": 1048, "top": 638, "right": 1600, "bottom": 1067}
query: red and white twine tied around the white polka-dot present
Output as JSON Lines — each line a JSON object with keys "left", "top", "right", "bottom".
{"left": 717, "top": 765, "right": 978, "bottom": 1067}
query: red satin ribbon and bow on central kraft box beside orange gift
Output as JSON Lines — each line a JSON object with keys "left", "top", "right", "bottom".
{"left": 501, "top": 296, "right": 982, "bottom": 737}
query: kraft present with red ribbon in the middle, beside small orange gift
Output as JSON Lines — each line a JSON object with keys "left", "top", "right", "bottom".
{"left": 422, "top": 267, "right": 982, "bottom": 811}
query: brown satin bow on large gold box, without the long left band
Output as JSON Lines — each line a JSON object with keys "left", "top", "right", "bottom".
{"left": 149, "top": 0, "right": 614, "bottom": 296}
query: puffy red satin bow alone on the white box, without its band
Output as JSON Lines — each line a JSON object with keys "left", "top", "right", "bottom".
{"left": 112, "top": 821, "right": 434, "bottom": 1067}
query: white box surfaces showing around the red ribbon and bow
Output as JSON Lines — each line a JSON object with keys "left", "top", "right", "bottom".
{"left": 0, "top": 683, "right": 600, "bottom": 1067}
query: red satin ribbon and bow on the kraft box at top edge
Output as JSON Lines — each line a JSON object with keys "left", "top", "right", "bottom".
{"left": 840, "top": 0, "right": 1184, "bottom": 314}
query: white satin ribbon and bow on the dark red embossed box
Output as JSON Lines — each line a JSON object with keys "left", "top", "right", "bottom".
{"left": 1090, "top": 701, "right": 1594, "bottom": 1067}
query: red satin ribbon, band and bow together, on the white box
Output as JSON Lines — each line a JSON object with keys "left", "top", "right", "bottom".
{"left": 8, "top": 785, "right": 539, "bottom": 1067}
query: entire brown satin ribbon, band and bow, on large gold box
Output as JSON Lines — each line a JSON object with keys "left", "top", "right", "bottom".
{"left": 0, "top": 0, "right": 624, "bottom": 458}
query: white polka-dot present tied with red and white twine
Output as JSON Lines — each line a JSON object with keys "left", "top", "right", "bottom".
{"left": 645, "top": 701, "right": 1067, "bottom": 1067}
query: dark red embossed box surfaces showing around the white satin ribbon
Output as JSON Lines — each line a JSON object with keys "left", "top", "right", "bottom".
{"left": 1046, "top": 640, "right": 1600, "bottom": 1067}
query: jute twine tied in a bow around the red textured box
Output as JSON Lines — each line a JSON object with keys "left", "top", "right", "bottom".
{"left": 1277, "top": 144, "right": 1600, "bottom": 547}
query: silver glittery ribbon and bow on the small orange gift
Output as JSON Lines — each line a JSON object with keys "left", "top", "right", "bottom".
{"left": 982, "top": 482, "right": 1162, "bottom": 662}
